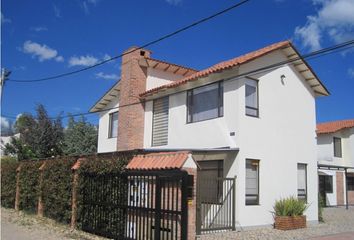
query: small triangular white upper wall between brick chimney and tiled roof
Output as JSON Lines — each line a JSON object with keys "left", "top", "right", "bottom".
{"left": 146, "top": 68, "right": 183, "bottom": 90}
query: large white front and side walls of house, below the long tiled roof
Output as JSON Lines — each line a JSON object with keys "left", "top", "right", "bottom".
{"left": 144, "top": 51, "right": 318, "bottom": 227}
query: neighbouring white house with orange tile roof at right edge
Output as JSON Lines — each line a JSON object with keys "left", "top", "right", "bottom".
{"left": 317, "top": 119, "right": 354, "bottom": 206}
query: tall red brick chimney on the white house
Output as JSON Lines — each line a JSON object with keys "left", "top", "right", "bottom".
{"left": 117, "top": 47, "right": 150, "bottom": 151}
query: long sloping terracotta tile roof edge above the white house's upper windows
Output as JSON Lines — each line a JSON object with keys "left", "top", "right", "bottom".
{"left": 140, "top": 41, "right": 292, "bottom": 97}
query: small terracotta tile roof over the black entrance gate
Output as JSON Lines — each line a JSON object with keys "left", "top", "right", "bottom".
{"left": 126, "top": 151, "right": 189, "bottom": 170}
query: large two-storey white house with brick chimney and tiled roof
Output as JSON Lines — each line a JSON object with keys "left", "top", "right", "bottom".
{"left": 90, "top": 41, "right": 329, "bottom": 227}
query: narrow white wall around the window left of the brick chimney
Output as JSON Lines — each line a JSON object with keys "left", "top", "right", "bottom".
{"left": 97, "top": 98, "right": 119, "bottom": 153}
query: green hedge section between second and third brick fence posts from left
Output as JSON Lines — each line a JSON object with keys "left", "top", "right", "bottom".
{"left": 41, "top": 157, "right": 77, "bottom": 223}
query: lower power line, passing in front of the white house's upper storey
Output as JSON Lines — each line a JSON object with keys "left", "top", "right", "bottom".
{"left": 3, "top": 39, "right": 354, "bottom": 122}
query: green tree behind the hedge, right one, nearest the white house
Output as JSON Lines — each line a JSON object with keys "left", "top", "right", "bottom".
{"left": 63, "top": 116, "right": 97, "bottom": 155}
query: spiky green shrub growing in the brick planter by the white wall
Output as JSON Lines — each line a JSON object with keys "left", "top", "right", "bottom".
{"left": 273, "top": 197, "right": 308, "bottom": 216}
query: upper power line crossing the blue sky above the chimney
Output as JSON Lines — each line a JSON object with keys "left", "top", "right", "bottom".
{"left": 8, "top": 0, "right": 250, "bottom": 83}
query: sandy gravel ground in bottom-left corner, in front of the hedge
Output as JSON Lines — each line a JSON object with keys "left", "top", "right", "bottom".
{"left": 1, "top": 208, "right": 105, "bottom": 240}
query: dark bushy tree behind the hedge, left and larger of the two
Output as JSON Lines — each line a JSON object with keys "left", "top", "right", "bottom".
{"left": 4, "top": 104, "right": 64, "bottom": 160}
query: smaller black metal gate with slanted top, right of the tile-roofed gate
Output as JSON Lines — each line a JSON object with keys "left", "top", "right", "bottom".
{"left": 197, "top": 178, "right": 236, "bottom": 234}
